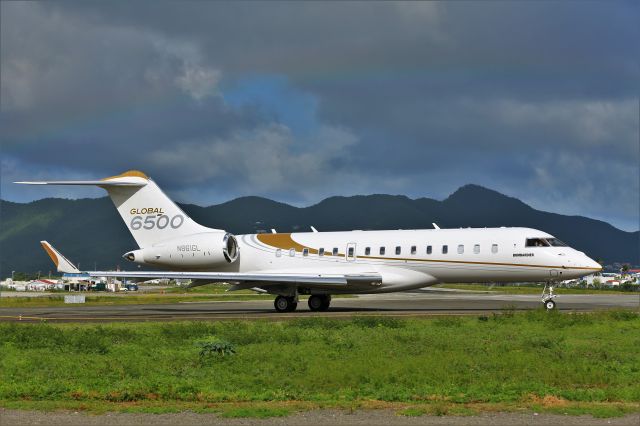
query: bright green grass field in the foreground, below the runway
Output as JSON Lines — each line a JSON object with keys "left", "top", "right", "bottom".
{"left": 0, "top": 311, "right": 640, "bottom": 417}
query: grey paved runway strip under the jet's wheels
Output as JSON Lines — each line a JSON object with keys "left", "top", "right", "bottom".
{"left": 0, "top": 290, "right": 640, "bottom": 322}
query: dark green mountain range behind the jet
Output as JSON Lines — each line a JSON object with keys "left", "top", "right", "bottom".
{"left": 0, "top": 185, "right": 640, "bottom": 277}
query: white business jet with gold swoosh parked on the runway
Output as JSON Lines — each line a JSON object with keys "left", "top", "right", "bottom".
{"left": 17, "top": 171, "right": 602, "bottom": 312}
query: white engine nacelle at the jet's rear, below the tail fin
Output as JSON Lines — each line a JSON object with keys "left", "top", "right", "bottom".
{"left": 122, "top": 232, "right": 240, "bottom": 269}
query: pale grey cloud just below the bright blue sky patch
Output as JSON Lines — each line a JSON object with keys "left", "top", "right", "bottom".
{"left": 150, "top": 123, "right": 357, "bottom": 193}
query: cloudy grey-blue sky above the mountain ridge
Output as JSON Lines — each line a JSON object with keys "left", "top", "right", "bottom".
{"left": 0, "top": 0, "right": 640, "bottom": 230}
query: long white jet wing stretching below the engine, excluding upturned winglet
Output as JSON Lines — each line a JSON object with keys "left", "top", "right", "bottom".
{"left": 89, "top": 271, "right": 382, "bottom": 288}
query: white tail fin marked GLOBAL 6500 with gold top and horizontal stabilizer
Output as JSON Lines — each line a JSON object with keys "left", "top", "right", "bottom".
{"left": 16, "top": 170, "right": 218, "bottom": 248}
